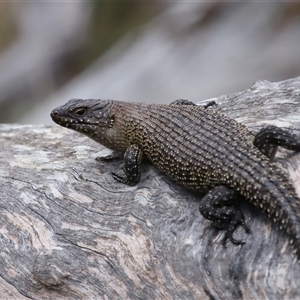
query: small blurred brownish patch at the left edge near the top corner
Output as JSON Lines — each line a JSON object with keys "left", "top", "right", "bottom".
{"left": 0, "top": 2, "right": 17, "bottom": 52}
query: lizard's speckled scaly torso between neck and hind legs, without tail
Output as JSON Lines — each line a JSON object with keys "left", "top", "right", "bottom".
{"left": 126, "top": 105, "right": 270, "bottom": 191}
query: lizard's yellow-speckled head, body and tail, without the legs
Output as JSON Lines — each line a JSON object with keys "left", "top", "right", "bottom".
{"left": 52, "top": 99, "right": 300, "bottom": 255}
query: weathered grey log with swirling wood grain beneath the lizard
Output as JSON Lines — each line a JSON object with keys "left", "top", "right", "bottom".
{"left": 0, "top": 77, "right": 300, "bottom": 299}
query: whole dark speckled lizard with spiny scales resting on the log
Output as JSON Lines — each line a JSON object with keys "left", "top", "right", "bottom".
{"left": 51, "top": 99, "right": 300, "bottom": 258}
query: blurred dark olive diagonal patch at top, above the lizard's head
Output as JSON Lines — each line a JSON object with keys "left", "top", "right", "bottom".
{"left": 56, "top": 0, "right": 164, "bottom": 85}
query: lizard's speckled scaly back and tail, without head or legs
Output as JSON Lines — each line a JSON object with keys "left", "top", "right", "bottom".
{"left": 125, "top": 104, "right": 300, "bottom": 253}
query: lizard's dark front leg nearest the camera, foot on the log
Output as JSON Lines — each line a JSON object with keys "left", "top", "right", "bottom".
{"left": 112, "top": 145, "right": 142, "bottom": 185}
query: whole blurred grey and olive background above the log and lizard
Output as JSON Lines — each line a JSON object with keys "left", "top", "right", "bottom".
{"left": 0, "top": 1, "right": 300, "bottom": 124}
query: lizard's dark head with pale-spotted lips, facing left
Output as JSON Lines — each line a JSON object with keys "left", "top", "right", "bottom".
{"left": 51, "top": 99, "right": 126, "bottom": 149}
